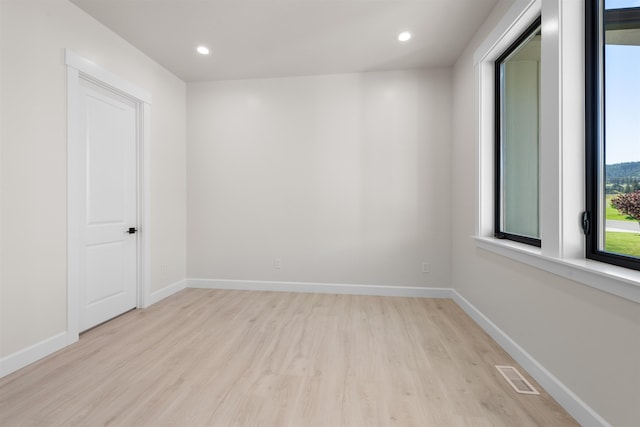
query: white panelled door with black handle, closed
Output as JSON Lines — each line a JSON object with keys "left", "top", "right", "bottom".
{"left": 79, "top": 79, "right": 138, "bottom": 331}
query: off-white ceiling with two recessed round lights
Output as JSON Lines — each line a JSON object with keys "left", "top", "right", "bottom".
{"left": 71, "top": 0, "right": 497, "bottom": 82}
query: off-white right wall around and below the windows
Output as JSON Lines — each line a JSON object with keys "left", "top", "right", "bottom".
{"left": 451, "top": 1, "right": 640, "bottom": 426}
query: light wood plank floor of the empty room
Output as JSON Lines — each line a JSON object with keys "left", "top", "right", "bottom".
{"left": 0, "top": 289, "right": 578, "bottom": 427}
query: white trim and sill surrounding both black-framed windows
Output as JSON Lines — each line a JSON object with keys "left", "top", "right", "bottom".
{"left": 474, "top": 0, "right": 640, "bottom": 303}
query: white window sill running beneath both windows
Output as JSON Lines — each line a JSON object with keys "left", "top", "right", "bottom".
{"left": 474, "top": 236, "right": 640, "bottom": 303}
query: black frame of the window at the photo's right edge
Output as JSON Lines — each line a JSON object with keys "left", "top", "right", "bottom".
{"left": 584, "top": 0, "right": 640, "bottom": 270}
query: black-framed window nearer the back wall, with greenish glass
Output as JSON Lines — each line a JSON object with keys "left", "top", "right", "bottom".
{"left": 495, "top": 18, "right": 541, "bottom": 246}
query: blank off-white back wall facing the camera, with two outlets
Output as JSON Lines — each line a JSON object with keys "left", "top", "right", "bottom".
{"left": 187, "top": 69, "right": 452, "bottom": 287}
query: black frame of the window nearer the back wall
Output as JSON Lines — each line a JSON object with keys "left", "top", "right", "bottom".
{"left": 494, "top": 15, "right": 542, "bottom": 247}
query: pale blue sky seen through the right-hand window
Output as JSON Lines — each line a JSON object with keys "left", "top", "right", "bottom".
{"left": 605, "top": 0, "right": 640, "bottom": 165}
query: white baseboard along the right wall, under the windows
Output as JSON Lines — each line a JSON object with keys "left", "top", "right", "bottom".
{"left": 451, "top": 289, "right": 611, "bottom": 427}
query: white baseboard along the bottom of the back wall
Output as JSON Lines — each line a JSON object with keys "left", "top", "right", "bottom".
{"left": 187, "top": 279, "right": 452, "bottom": 298}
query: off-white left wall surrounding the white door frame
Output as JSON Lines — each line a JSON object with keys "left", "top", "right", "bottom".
{"left": 0, "top": 0, "right": 186, "bottom": 357}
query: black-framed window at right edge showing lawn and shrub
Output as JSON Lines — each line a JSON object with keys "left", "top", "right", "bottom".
{"left": 584, "top": 0, "right": 640, "bottom": 270}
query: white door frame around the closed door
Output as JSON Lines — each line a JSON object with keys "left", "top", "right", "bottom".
{"left": 65, "top": 49, "right": 151, "bottom": 344}
